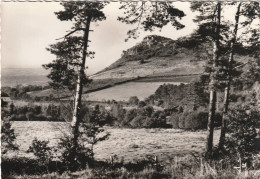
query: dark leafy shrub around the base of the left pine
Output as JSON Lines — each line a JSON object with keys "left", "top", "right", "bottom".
{"left": 58, "top": 110, "right": 110, "bottom": 171}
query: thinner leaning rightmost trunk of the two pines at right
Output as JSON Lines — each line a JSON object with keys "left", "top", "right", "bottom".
{"left": 218, "top": 2, "right": 242, "bottom": 148}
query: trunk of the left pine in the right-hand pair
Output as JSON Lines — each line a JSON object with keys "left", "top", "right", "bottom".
{"left": 206, "top": 2, "right": 221, "bottom": 154}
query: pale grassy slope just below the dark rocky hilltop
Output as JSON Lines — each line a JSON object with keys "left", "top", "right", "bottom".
{"left": 93, "top": 56, "right": 205, "bottom": 79}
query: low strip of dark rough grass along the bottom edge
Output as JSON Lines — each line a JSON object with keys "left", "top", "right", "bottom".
{"left": 2, "top": 152, "right": 260, "bottom": 179}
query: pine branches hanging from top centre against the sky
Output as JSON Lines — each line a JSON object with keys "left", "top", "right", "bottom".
{"left": 118, "top": 1, "right": 185, "bottom": 40}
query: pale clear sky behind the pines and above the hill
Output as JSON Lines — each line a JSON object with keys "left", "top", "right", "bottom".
{"left": 1, "top": 2, "right": 202, "bottom": 74}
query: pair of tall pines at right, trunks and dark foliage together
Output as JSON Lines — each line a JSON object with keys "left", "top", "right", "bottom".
{"left": 191, "top": 2, "right": 260, "bottom": 153}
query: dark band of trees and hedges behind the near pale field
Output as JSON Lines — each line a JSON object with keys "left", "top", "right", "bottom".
{"left": 2, "top": 83, "right": 220, "bottom": 129}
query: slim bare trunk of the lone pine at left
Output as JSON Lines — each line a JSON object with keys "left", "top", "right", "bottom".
{"left": 71, "top": 17, "right": 91, "bottom": 150}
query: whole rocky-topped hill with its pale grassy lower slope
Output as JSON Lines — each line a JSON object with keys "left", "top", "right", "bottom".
{"left": 91, "top": 35, "right": 206, "bottom": 79}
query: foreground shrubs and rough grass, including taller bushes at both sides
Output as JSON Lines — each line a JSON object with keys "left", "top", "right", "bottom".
{"left": 2, "top": 103, "right": 260, "bottom": 179}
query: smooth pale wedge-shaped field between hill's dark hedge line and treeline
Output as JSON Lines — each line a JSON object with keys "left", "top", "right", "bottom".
{"left": 83, "top": 82, "right": 180, "bottom": 101}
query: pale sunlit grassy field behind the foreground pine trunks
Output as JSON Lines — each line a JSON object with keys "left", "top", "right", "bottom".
{"left": 10, "top": 121, "right": 219, "bottom": 162}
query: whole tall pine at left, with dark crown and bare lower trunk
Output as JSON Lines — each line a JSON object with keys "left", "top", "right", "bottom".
{"left": 43, "top": 2, "right": 107, "bottom": 162}
